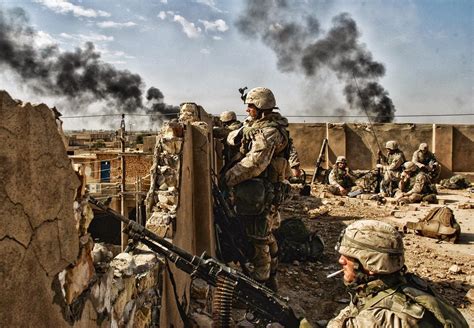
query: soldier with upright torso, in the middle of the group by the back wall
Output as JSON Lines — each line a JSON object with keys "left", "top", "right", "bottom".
{"left": 377, "top": 140, "right": 405, "bottom": 197}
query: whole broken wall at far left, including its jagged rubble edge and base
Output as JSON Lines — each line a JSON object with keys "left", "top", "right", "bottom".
{"left": 0, "top": 91, "right": 162, "bottom": 328}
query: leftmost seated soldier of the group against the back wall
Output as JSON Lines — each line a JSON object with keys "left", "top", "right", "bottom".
{"left": 328, "top": 156, "right": 357, "bottom": 196}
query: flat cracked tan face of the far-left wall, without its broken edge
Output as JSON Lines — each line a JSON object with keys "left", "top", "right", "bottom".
{"left": 0, "top": 91, "right": 79, "bottom": 327}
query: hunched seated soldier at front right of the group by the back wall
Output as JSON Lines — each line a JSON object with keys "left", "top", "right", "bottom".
{"left": 395, "top": 162, "right": 438, "bottom": 203}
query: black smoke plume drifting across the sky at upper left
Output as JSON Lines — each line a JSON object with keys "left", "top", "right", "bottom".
{"left": 0, "top": 8, "right": 177, "bottom": 119}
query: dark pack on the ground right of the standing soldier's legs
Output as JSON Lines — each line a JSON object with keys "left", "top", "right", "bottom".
{"left": 274, "top": 218, "right": 324, "bottom": 263}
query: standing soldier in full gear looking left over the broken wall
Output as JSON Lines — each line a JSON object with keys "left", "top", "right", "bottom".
{"left": 225, "top": 87, "right": 291, "bottom": 290}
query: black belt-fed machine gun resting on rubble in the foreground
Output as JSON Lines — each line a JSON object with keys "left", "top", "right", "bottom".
{"left": 89, "top": 197, "right": 300, "bottom": 328}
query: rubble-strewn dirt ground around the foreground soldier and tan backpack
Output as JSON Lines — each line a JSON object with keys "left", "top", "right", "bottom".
{"left": 279, "top": 185, "right": 474, "bottom": 327}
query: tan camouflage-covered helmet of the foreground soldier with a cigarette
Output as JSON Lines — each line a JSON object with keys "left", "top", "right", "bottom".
{"left": 335, "top": 220, "right": 405, "bottom": 274}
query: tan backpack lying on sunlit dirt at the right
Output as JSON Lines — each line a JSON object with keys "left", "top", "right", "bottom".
{"left": 404, "top": 206, "right": 461, "bottom": 243}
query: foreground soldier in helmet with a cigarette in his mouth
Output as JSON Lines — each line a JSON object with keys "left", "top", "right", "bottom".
{"left": 327, "top": 220, "right": 468, "bottom": 328}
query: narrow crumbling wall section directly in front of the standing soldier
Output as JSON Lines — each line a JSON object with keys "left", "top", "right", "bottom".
{"left": 146, "top": 103, "right": 214, "bottom": 327}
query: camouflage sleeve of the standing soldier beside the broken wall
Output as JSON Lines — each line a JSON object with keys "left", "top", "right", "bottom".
{"left": 225, "top": 127, "right": 285, "bottom": 187}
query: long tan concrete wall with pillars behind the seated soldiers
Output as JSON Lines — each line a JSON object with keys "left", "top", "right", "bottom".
{"left": 290, "top": 123, "right": 474, "bottom": 177}
